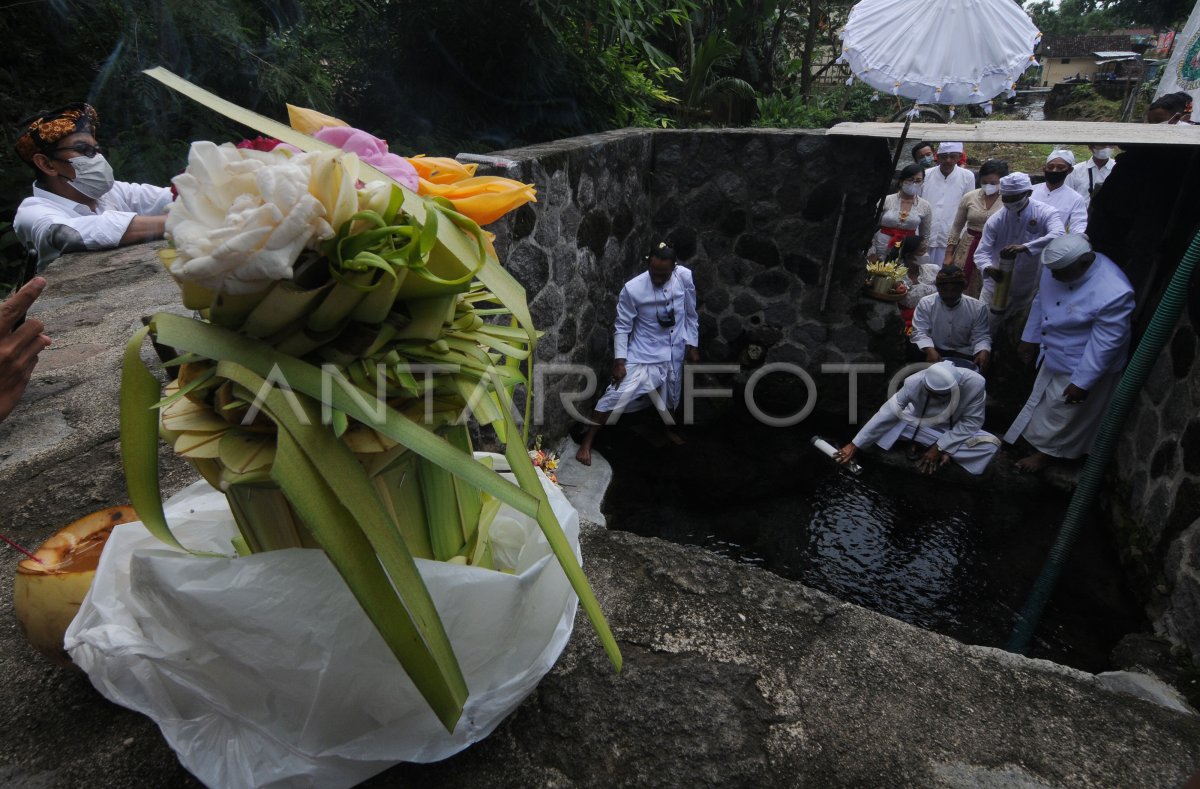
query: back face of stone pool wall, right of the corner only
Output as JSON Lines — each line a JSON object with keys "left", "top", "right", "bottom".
{"left": 650, "top": 130, "right": 901, "bottom": 414}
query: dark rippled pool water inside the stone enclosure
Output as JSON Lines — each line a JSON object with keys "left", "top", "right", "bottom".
{"left": 598, "top": 405, "right": 1145, "bottom": 671}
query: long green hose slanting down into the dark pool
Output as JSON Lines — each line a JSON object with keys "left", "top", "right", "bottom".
{"left": 1007, "top": 225, "right": 1200, "bottom": 655}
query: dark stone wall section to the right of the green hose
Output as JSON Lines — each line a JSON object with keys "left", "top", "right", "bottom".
{"left": 1108, "top": 306, "right": 1200, "bottom": 659}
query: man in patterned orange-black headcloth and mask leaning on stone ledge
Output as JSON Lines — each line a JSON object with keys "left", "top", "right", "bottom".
{"left": 13, "top": 103, "right": 172, "bottom": 271}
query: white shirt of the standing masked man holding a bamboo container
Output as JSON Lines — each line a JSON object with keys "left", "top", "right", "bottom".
{"left": 976, "top": 199, "right": 1066, "bottom": 314}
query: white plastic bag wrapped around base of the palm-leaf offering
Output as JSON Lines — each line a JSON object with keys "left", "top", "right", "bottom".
{"left": 65, "top": 456, "right": 578, "bottom": 788}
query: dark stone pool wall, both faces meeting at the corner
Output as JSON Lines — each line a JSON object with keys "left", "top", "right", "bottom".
{"left": 490, "top": 130, "right": 900, "bottom": 435}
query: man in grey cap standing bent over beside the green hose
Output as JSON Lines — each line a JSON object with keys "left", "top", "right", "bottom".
{"left": 1004, "top": 234, "right": 1134, "bottom": 471}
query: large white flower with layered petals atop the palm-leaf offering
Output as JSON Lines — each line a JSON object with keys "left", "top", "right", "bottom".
{"left": 167, "top": 141, "right": 358, "bottom": 294}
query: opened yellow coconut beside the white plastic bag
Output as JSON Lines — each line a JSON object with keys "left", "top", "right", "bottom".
{"left": 12, "top": 506, "right": 138, "bottom": 665}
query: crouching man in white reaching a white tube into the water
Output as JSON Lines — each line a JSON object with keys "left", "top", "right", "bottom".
{"left": 834, "top": 361, "right": 1000, "bottom": 475}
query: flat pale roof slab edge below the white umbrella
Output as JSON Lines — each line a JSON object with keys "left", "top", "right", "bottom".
{"left": 826, "top": 121, "right": 1200, "bottom": 145}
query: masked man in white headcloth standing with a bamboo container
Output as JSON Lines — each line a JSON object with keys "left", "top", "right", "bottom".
{"left": 976, "top": 173, "right": 1063, "bottom": 333}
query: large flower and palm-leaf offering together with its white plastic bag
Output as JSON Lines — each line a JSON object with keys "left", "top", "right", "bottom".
{"left": 58, "top": 68, "right": 620, "bottom": 785}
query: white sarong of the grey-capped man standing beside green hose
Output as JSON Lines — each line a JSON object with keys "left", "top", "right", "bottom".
{"left": 1004, "top": 365, "right": 1121, "bottom": 459}
